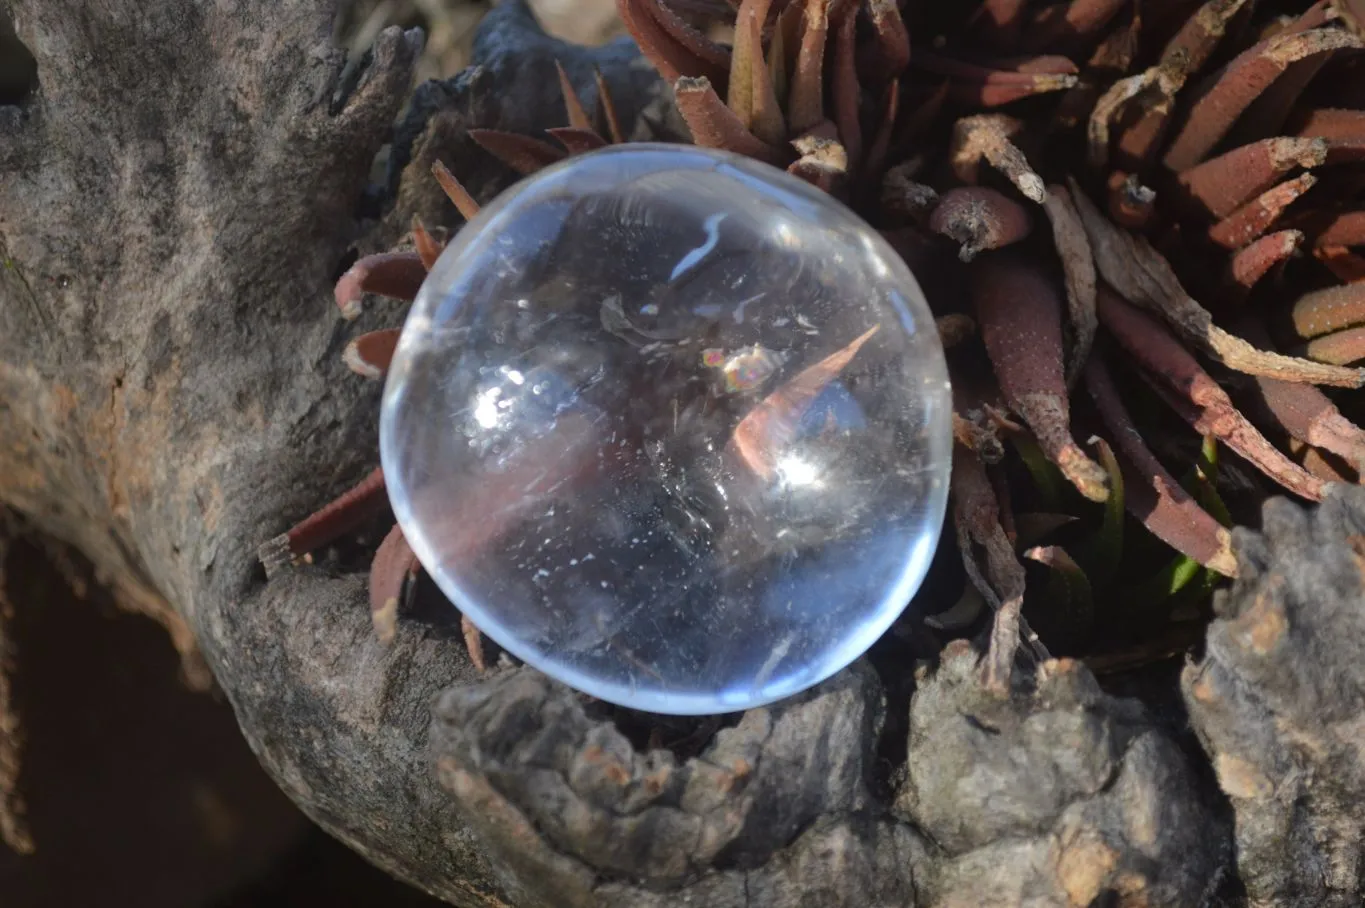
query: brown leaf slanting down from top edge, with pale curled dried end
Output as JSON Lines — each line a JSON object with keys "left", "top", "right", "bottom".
{"left": 1091, "top": 0, "right": 1248, "bottom": 172}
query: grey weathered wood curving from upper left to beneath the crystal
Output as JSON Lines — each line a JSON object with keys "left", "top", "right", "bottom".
{"left": 0, "top": 0, "right": 1365, "bottom": 907}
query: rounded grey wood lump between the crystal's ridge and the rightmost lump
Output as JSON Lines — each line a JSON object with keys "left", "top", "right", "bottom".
{"left": 893, "top": 642, "right": 1229, "bottom": 908}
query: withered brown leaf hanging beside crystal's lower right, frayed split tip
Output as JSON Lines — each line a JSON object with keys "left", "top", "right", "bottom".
{"left": 951, "top": 445, "right": 1046, "bottom": 695}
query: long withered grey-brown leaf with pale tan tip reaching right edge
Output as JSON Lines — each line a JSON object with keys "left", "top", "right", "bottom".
{"left": 1070, "top": 179, "right": 1365, "bottom": 388}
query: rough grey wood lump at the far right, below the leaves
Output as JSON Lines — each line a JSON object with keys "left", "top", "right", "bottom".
{"left": 1182, "top": 485, "right": 1365, "bottom": 907}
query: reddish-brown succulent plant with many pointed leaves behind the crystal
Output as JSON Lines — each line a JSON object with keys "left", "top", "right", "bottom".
{"left": 265, "top": 0, "right": 1365, "bottom": 688}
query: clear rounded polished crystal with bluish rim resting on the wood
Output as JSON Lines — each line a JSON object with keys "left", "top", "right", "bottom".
{"left": 379, "top": 145, "right": 951, "bottom": 714}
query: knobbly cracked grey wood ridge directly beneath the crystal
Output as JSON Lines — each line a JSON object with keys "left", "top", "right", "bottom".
{"left": 431, "top": 662, "right": 931, "bottom": 908}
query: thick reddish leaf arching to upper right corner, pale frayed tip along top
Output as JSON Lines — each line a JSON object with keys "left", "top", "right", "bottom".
{"left": 1163, "top": 29, "right": 1362, "bottom": 173}
